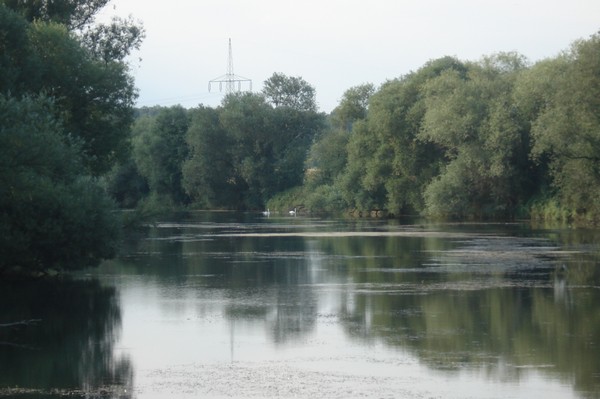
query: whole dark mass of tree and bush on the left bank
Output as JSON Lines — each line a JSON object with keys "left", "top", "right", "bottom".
{"left": 0, "top": 0, "right": 143, "bottom": 274}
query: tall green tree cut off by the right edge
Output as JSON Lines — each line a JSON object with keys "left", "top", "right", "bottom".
{"left": 519, "top": 34, "right": 600, "bottom": 221}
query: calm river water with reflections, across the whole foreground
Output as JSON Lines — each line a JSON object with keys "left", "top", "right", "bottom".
{"left": 0, "top": 212, "right": 600, "bottom": 399}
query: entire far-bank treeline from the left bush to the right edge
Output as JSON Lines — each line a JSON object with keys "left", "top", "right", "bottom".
{"left": 106, "top": 35, "right": 600, "bottom": 224}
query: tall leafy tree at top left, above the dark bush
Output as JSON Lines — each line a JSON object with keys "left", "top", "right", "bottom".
{"left": 0, "top": 0, "right": 143, "bottom": 175}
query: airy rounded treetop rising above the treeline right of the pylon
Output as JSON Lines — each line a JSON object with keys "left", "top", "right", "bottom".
{"left": 262, "top": 73, "right": 317, "bottom": 111}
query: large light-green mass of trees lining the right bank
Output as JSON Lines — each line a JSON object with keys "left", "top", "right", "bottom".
{"left": 298, "top": 35, "right": 600, "bottom": 223}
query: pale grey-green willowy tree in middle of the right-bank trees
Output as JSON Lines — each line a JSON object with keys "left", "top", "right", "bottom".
{"left": 420, "top": 54, "right": 531, "bottom": 217}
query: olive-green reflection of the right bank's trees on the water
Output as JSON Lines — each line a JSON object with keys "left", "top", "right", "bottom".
{"left": 336, "top": 236, "right": 600, "bottom": 397}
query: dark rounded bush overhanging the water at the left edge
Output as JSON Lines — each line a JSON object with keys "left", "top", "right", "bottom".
{"left": 0, "top": 96, "right": 119, "bottom": 273}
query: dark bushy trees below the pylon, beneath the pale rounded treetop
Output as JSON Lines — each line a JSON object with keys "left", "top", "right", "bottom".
{"left": 183, "top": 93, "right": 323, "bottom": 209}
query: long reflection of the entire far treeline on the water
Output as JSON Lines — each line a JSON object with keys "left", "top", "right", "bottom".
{"left": 94, "top": 219, "right": 600, "bottom": 397}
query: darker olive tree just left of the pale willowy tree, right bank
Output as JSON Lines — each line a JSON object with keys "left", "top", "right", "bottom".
{"left": 341, "top": 57, "right": 466, "bottom": 214}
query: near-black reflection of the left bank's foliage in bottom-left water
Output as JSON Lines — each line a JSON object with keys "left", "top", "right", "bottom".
{"left": 0, "top": 280, "right": 133, "bottom": 397}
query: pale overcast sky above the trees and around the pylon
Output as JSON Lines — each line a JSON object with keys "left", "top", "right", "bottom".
{"left": 99, "top": 0, "right": 600, "bottom": 112}
